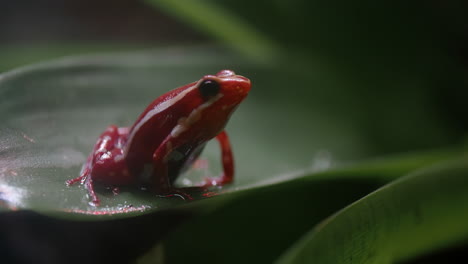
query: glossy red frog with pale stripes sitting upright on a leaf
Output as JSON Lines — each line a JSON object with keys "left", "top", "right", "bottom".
{"left": 66, "top": 70, "right": 250, "bottom": 206}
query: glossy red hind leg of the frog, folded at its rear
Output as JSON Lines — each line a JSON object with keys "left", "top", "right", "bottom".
{"left": 66, "top": 125, "right": 130, "bottom": 205}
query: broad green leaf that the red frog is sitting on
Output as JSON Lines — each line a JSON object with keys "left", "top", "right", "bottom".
{"left": 0, "top": 48, "right": 361, "bottom": 219}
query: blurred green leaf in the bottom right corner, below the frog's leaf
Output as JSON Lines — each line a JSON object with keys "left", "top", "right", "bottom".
{"left": 277, "top": 158, "right": 468, "bottom": 263}
